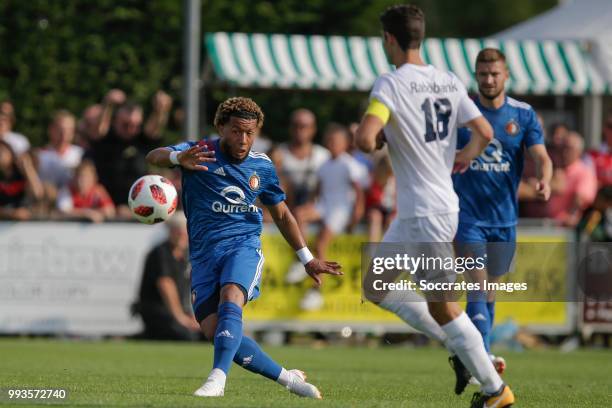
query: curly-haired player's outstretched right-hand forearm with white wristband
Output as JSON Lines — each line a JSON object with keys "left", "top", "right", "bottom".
{"left": 267, "top": 201, "right": 342, "bottom": 286}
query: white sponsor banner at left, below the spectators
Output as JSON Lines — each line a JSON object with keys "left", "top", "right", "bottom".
{"left": 0, "top": 222, "right": 165, "bottom": 336}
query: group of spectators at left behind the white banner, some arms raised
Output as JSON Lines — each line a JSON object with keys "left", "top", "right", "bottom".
{"left": 0, "top": 89, "right": 177, "bottom": 222}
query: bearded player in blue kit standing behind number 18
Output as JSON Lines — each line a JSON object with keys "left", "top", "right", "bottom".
{"left": 453, "top": 48, "right": 552, "bottom": 379}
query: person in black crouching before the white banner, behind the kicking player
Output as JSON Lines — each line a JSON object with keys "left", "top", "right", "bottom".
{"left": 135, "top": 212, "right": 200, "bottom": 341}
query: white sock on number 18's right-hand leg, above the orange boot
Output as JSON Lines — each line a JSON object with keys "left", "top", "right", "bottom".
{"left": 442, "top": 313, "right": 503, "bottom": 394}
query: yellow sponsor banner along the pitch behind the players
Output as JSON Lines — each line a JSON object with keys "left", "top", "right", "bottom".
{"left": 245, "top": 232, "right": 573, "bottom": 332}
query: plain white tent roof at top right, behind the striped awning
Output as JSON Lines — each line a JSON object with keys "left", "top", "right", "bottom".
{"left": 495, "top": 0, "right": 612, "bottom": 82}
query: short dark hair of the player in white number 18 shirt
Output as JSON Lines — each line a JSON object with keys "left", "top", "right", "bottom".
{"left": 380, "top": 4, "right": 425, "bottom": 51}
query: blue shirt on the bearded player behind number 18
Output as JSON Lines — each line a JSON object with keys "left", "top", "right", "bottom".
{"left": 453, "top": 97, "right": 544, "bottom": 227}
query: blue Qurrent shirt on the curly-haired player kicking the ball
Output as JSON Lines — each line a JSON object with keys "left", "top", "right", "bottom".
{"left": 168, "top": 140, "right": 285, "bottom": 264}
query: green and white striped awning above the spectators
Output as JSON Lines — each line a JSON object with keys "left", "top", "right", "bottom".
{"left": 206, "top": 32, "right": 611, "bottom": 95}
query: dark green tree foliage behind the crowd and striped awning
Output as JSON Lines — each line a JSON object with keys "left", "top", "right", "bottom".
{"left": 0, "top": 0, "right": 556, "bottom": 144}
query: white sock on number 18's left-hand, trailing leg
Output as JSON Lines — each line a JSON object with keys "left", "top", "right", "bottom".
{"left": 379, "top": 290, "right": 448, "bottom": 348}
